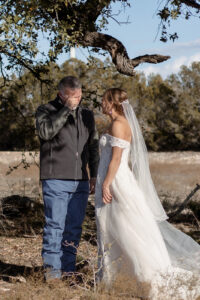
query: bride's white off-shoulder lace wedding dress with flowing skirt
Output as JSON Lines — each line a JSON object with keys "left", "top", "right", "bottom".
{"left": 95, "top": 134, "right": 200, "bottom": 300}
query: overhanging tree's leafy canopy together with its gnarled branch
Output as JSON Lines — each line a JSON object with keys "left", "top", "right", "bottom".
{"left": 0, "top": 0, "right": 200, "bottom": 80}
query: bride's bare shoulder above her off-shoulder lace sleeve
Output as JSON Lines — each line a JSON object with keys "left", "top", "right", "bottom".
{"left": 111, "top": 117, "right": 131, "bottom": 141}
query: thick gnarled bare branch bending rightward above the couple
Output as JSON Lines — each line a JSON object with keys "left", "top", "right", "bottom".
{"left": 81, "top": 32, "right": 170, "bottom": 76}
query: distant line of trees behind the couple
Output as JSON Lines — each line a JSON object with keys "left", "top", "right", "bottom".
{"left": 0, "top": 58, "right": 200, "bottom": 151}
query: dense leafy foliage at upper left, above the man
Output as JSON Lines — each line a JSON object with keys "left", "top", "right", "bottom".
{"left": 0, "top": 0, "right": 128, "bottom": 78}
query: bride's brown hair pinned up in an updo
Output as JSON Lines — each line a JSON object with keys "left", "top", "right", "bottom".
{"left": 103, "top": 88, "right": 128, "bottom": 115}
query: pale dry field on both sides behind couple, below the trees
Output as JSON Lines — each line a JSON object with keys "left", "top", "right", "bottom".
{"left": 0, "top": 151, "right": 200, "bottom": 202}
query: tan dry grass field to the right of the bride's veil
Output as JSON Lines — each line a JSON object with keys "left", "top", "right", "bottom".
{"left": 149, "top": 152, "right": 200, "bottom": 203}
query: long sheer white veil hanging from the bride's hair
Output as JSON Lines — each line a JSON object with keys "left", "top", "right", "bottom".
{"left": 122, "top": 100, "right": 168, "bottom": 221}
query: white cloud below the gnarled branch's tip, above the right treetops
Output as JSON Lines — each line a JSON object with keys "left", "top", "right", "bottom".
{"left": 137, "top": 52, "right": 200, "bottom": 78}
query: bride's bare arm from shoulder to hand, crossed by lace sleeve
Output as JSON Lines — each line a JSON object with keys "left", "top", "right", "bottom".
{"left": 102, "top": 121, "right": 125, "bottom": 204}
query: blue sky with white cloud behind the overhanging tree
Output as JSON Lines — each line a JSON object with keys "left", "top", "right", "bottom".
{"left": 47, "top": 0, "right": 200, "bottom": 78}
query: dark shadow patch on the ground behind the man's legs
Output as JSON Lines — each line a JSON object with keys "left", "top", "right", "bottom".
{"left": 0, "top": 195, "right": 96, "bottom": 241}
